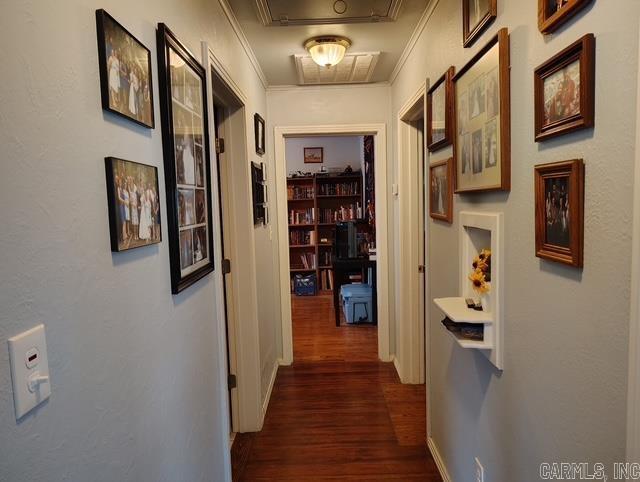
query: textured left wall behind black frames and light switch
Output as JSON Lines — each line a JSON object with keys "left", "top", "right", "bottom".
{"left": 0, "top": 0, "right": 266, "bottom": 482}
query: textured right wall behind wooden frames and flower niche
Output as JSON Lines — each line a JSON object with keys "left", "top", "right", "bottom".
{"left": 392, "top": 0, "right": 640, "bottom": 482}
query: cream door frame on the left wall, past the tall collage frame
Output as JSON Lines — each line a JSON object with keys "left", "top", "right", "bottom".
{"left": 202, "top": 42, "right": 264, "bottom": 440}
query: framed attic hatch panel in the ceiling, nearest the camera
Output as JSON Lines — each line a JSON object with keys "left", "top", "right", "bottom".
{"left": 255, "top": 0, "right": 402, "bottom": 27}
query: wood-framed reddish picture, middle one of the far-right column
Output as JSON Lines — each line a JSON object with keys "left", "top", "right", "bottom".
{"left": 534, "top": 34, "right": 596, "bottom": 141}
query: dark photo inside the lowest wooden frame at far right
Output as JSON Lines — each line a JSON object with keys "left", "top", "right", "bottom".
{"left": 544, "top": 176, "right": 571, "bottom": 248}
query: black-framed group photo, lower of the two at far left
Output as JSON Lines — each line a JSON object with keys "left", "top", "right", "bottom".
{"left": 105, "top": 157, "right": 162, "bottom": 252}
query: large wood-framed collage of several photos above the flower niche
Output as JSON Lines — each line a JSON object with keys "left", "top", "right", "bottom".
{"left": 453, "top": 28, "right": 511, "bottom": 193}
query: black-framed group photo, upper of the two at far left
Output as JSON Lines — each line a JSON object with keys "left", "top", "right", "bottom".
{"left": 96, "top": 9, "right": 155, "bottom": 129}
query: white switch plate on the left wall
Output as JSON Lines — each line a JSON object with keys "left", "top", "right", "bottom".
{"left": 9, "top": 325, "right": 51, "bottom": 420}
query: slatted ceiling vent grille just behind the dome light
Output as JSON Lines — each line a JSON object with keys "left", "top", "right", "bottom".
{"left": 294, "top": 52, "right": 380, "bottom": 85}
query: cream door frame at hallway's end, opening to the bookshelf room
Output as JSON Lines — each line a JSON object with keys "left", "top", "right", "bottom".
{"left": 274, "top": 124, "right": 392, "bottom": 365}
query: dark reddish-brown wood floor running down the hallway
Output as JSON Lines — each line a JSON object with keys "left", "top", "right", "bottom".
{"left": 231, "top": 295, "right": 442, "bottom": 482}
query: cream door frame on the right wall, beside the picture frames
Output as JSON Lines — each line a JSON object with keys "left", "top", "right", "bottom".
{"left": 394, "top": 81, "right": 429, "bottom": 390}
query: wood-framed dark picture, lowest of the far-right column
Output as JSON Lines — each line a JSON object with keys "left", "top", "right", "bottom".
{"left": 535, "top": 159, "right": 584, "bottom": 268}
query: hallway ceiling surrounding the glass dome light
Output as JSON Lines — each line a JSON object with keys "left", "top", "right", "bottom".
{"left": 229, "top": 0, "right": 428, "bottom": 85}
